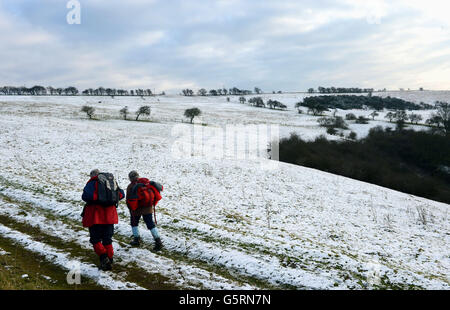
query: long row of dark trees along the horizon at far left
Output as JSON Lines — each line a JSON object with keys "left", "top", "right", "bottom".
{"left": 0, "top": 85, "right": 165, "bottom": 97}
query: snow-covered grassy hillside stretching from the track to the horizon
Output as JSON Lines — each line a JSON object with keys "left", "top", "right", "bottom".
{"left": 0, "top": 92, "right": 450, "bottom": 289}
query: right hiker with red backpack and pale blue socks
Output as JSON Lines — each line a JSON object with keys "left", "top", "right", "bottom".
{"left": 126, "top": 171, "right": 163, "bottom": 251}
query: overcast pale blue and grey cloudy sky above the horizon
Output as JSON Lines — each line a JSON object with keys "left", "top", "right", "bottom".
{"left": 0, "top": 0, "right": 450, "bottom": 92}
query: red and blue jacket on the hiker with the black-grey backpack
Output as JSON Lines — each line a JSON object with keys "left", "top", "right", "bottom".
{"left": 82, "top": 177, "right": 125, "bottom": 227}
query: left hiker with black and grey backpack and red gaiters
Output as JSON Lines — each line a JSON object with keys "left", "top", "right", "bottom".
{"left": 81, "top": 169, "right": 125, "bottom": 271}
